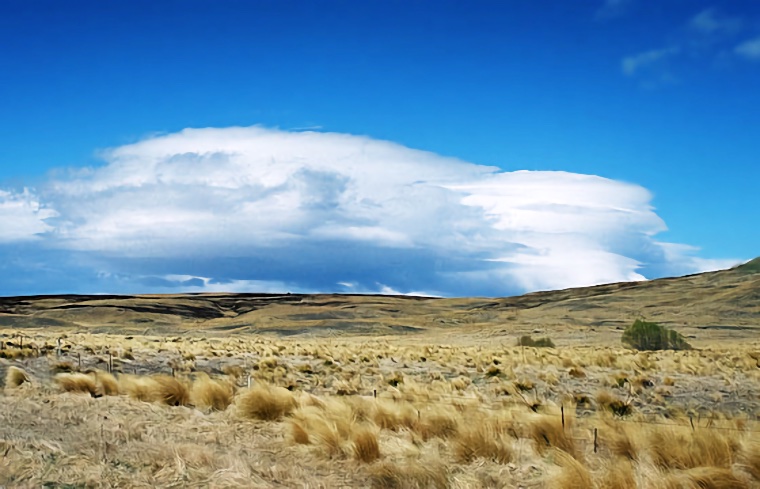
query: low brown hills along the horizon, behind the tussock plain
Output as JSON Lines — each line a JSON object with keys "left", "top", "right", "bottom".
{"left": 0, "top": 259, "right": 760, "bottom": 341}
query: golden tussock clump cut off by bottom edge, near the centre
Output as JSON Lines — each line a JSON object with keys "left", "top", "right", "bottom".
{"left": 368, "top": 460, "right": 450, "bottom": 489}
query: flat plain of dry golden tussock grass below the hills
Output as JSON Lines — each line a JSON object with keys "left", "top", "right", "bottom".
{"left": 0, "top": 328, "right": 760, "bottom": 489}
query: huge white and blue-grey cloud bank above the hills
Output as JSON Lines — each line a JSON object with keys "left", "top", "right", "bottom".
{"left": 0, "top": 127, "right": 740, "bottom": 295}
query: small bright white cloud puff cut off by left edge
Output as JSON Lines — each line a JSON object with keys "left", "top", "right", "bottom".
{"left": 0, "top": 189, "right": 56, "bottom": 243}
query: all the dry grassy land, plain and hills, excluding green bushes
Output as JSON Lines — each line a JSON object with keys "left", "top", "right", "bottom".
{"left": 0, "top": 262, "right": 760, "bottom": 488}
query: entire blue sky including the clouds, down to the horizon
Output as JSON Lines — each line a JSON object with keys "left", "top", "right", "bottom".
{"left": 0, "top": 0, "right": 760, "bottom": 295}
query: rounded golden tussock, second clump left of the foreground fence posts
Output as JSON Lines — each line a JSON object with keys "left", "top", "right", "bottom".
{"left": 454, "top": 422, "right": 514, "bottom": 464}
